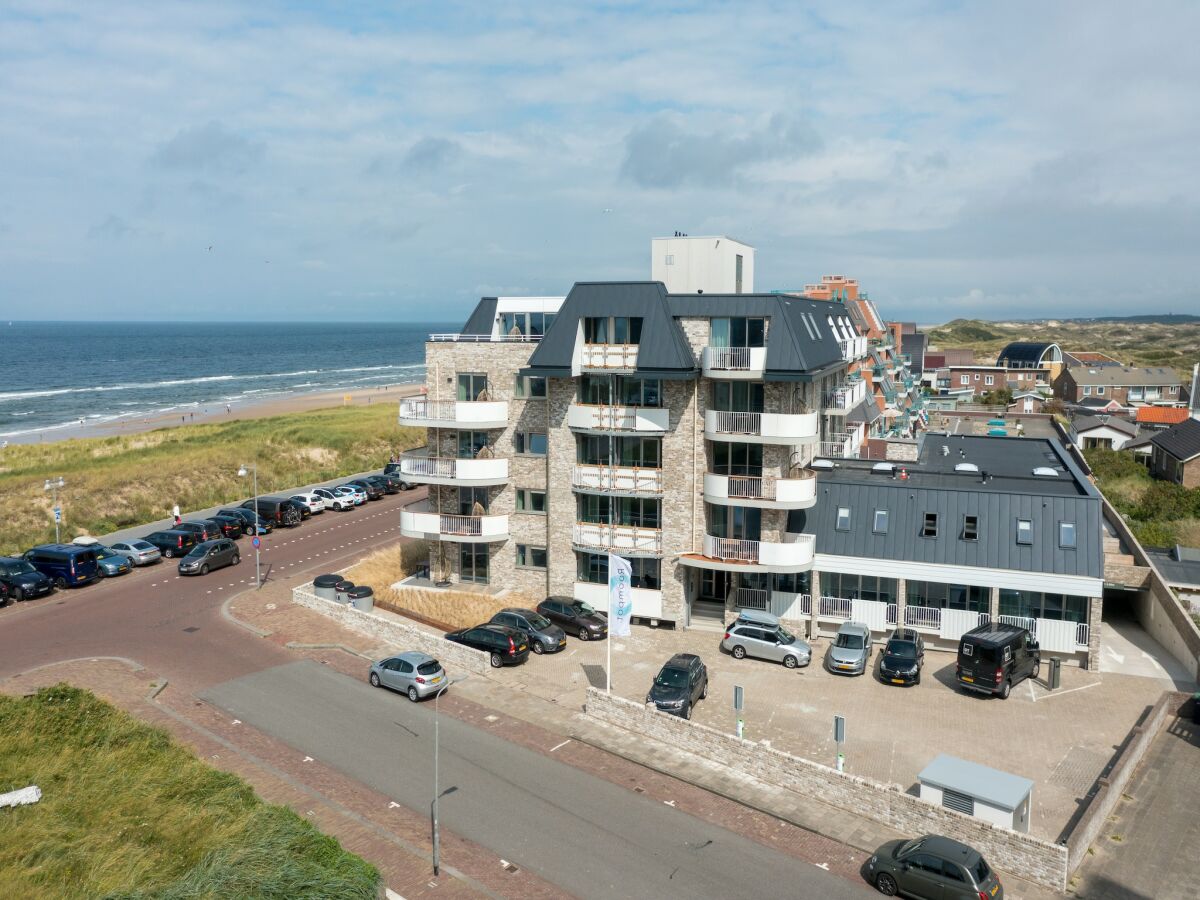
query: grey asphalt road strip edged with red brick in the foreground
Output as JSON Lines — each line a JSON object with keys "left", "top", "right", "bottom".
{"left": 203, "top": 661, "right": 872, "bottom": 900}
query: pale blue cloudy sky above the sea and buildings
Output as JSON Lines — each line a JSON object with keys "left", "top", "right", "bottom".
{"left": 0, "top": 0, "right": 1200, "bottom": 323}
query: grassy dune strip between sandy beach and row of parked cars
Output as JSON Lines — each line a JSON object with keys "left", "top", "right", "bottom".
{"left": 0, "top": 403, "right": 425, "bottom": 554}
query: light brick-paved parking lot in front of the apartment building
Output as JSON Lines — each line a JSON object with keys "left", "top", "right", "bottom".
{"left": 496, "top": 626, "right": 1164, "bottom": 840}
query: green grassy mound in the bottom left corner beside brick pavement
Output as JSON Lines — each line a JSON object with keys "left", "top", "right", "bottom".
{"left": 0, "top": 684, "right": 379, "bottom": 900}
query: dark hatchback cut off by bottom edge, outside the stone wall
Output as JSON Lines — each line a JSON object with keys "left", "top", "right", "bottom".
{"left": 865, "top": 834, "right": 1004, "bottom": 900}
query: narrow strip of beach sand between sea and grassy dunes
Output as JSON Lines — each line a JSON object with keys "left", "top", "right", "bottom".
{"left": 7, "top": 384, "right": 424, "bottom": 444}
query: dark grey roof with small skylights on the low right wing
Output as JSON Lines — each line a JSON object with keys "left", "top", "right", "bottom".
{"left": 788, "top": 434, "right": 1104, "bottom": 578}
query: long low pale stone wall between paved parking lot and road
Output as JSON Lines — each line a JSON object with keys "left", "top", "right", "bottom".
{"left": 586, "top": 688, "right": 1068, "bottom": 890}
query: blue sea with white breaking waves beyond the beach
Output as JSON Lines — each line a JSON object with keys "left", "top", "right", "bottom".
{"left": 0, "top": 322, "right": 461, "bottom": 440}
